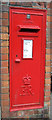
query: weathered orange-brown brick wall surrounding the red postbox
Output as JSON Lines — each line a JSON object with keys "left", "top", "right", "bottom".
{"left": 0, "top": 2, "right": 52, "bottom": 119}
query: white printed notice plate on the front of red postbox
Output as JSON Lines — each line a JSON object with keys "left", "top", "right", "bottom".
{"left": 23, "top": 40, "right": 33, "bottom": 58}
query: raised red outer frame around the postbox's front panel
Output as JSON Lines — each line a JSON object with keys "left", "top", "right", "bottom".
{"left": 9, "top": 7, "right": 47, "bottom": 111}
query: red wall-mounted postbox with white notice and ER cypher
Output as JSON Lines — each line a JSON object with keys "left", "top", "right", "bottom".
{"left": 10, "top": 7, "right": 46, "bottom": 111}
